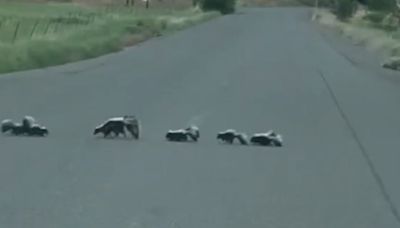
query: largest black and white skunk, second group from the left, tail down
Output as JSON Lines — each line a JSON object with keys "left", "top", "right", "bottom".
{"left": 93, "top": 116, "right": 140, "bottom": 139}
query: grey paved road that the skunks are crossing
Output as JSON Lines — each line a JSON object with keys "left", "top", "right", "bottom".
{"left": 0, "top": 8, "right": 400, "bottom": 228}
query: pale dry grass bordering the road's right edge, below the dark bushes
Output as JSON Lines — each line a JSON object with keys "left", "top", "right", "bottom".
{"left": 314, "top": 9, "right": 400, "bottom": 68}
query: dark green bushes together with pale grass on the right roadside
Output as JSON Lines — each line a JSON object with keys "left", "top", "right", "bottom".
{"left": 314, "top": 0, "right": 400, "bottom": 70}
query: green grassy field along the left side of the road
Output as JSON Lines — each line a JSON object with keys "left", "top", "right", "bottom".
{"left": 0, "top": 2, "right": 218, "bottom": 73}
